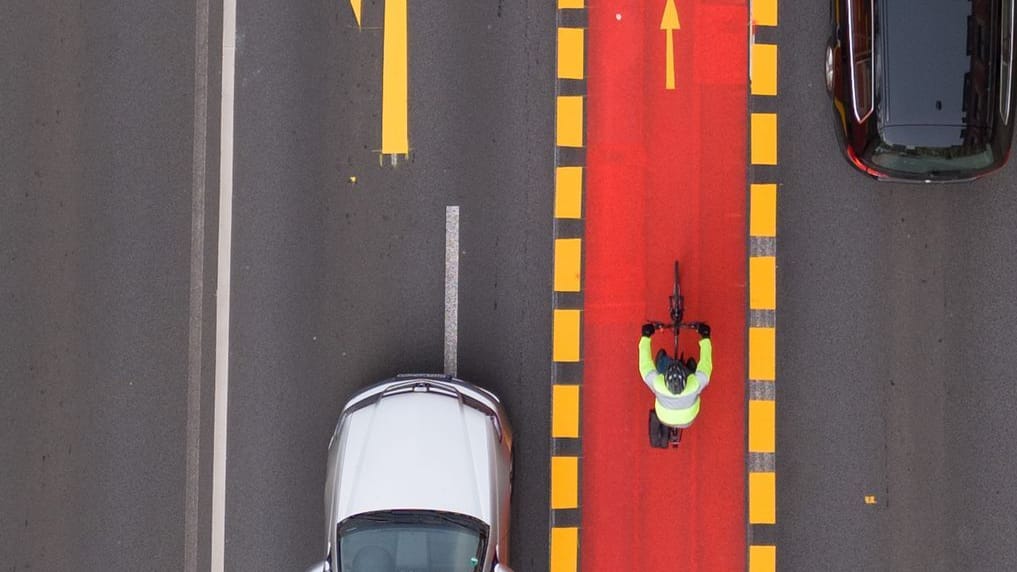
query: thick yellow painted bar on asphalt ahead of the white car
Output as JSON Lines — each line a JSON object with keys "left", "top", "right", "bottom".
{"left": 381, "top": 0, "right": 410, "bottom": 155}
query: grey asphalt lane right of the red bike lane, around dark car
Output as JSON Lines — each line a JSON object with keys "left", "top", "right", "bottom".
{"left": 775, "top": 2, "right": 1017, "bottom": 571}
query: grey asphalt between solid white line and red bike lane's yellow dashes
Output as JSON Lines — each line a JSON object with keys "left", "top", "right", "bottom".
{"left": 226, "top": 1, "right": 555, "bottom": 570}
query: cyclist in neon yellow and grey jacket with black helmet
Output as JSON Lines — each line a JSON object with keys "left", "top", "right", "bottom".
{"left": 639, "top": 322, "right": 713, "bottom": 428}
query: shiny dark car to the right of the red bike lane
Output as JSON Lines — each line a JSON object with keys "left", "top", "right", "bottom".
{"left": 826, "top": 0, "right": 1017, "bottom": 182}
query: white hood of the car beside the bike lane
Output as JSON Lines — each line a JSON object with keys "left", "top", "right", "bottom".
{"left": 336, "top": 392, "right": 496, "bottom": 524}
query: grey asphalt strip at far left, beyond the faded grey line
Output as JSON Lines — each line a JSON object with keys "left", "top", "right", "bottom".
{"left": 0, "top": 0, "right": 218, "bottom": 570}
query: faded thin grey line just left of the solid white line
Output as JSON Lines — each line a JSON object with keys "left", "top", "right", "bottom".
{"left": 184, "top": 0, "right": 208, "bottom": 572}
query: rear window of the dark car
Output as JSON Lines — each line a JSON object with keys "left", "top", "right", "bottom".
{"left": 872, "top": 142, "right": 996, "bottom": 176}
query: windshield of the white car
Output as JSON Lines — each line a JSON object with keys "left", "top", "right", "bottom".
{"left": 339, "top": 510, "right": 487, "bottom": 572}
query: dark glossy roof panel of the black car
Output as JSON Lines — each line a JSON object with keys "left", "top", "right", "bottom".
{"left": 876, "top": 0, "right": 988, "bottom": 128}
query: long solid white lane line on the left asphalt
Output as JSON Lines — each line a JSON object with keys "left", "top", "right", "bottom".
{"left": 211, "top": 0, "right": 237, "bottom": 572}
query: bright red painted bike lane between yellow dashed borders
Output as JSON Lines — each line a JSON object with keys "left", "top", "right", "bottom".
{"left": 580, "top": 0, "right": 749, "bottom": 572}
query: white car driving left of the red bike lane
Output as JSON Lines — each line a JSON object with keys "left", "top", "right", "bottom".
{"left": 311, "top": 375, "right": 513, "bottom": 572}
